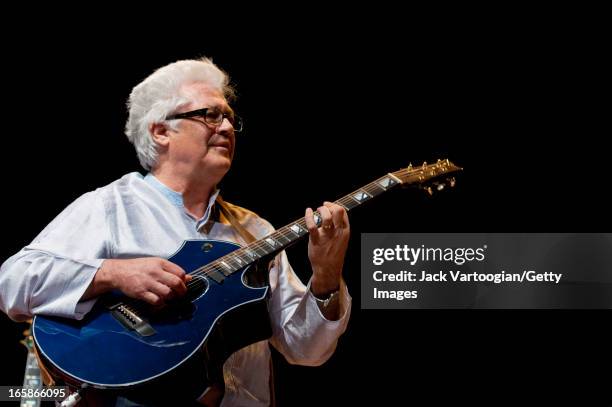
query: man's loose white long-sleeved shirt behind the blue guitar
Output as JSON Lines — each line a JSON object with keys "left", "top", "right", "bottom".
{"left": 0, "top": 172, "right": 351, "bottom": 406}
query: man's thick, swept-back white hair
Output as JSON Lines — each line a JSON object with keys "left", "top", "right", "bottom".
{"left": 125, "top": 58, "right": 235, "bottom": 171}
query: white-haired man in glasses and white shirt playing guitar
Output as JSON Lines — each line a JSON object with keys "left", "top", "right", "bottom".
{"left": 0, "top": 59, "right": 351, "bottom": 406}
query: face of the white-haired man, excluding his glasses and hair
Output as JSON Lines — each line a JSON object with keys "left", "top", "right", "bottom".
{"left": 168, "top": 83, "right": 236, "bottom": 177}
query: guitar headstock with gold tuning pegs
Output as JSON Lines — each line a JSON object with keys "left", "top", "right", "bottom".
{"left": 391, "top": 159, "right": 463, "bottom": 195}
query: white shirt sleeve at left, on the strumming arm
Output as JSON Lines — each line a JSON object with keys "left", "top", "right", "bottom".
{"left": 0, "top": 191, "right": 110, "bottom": 321}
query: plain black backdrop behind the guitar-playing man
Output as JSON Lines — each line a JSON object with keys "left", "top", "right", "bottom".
{"left": 0, "top": 10, "right": 612, "bottom": 406}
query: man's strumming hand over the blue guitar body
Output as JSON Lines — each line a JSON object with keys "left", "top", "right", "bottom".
{"left": 81, "top": 257, "right": 191, "bottom": 306}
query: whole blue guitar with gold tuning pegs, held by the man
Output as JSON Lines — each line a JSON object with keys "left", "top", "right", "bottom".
{"left": 33, "top": 160, "right": 460, "bottom": 404}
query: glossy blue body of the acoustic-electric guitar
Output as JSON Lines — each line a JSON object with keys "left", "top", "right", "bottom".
{"left": 33, "top": 240, "right": 272, "bottom": 404}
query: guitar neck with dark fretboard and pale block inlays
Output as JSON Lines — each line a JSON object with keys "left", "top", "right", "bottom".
{"left": 205, "top": 174, "right": 402, "bottom": 281}
